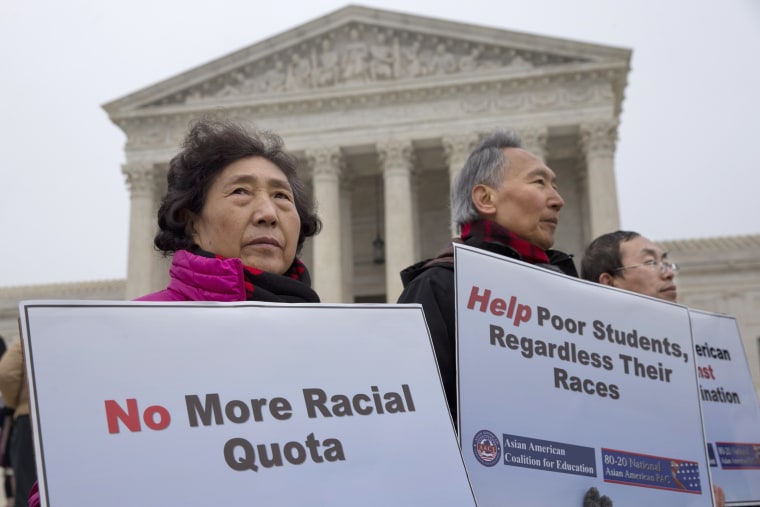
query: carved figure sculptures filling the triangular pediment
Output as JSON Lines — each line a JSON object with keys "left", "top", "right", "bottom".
{"left": 147, "top": 23, "right": 583, "bottom": 106}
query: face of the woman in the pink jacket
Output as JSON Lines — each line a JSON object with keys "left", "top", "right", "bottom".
{"left": 188, "top": 157, "right": 301, "bottom": 275}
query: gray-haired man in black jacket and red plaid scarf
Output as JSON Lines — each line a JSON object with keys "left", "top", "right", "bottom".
{"left": 398, "top": 130, "right": 578, "bottom": 421}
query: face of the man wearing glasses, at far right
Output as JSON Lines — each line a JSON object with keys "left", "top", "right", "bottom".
{"left": 610, "top": 236, "right": 678, "bottom": 302}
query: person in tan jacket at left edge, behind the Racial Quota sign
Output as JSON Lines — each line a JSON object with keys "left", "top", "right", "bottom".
{"left": 0, "top": 339, "right": 37, "bottom": 507}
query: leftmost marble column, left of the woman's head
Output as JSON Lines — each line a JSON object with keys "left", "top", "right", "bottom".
{"left": 121, "top": 162, "right": 157, "bottom": 299}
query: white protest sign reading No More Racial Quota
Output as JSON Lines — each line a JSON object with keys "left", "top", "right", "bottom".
{"left": 20, "top": 301, "right": 474, "bottom": 507}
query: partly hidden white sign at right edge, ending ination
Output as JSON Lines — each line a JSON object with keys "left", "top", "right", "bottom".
{"left": 689, "top": 310, "right": 760, "bottom": 505}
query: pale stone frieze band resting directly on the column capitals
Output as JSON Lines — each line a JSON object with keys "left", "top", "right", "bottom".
{"left": 117, "top": 71, "right": 616, "bottom": 166}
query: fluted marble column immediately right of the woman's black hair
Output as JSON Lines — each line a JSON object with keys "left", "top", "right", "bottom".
{"left": 306, "top": 146, "right": 343, "bottom": 303}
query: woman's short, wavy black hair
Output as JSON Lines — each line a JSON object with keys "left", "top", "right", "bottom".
{"left": 153, "top": 119, "right": 322, "bottom": 255}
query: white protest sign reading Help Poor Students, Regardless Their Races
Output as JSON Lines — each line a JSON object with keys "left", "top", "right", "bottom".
{"left": 455, "top": 245, "right": 712, "bottom": 507}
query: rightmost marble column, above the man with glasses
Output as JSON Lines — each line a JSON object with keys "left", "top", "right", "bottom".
{"left": 581, "top": 121, "right": 620, "bottom": 243}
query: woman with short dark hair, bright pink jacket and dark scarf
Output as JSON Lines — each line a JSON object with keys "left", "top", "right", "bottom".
{"left": 138, "top": 120, "right": 322, "bottom": 303}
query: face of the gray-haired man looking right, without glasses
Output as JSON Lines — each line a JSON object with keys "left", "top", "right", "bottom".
{"left": 488, "top": 148, "right": 565, "bottom": 250}
